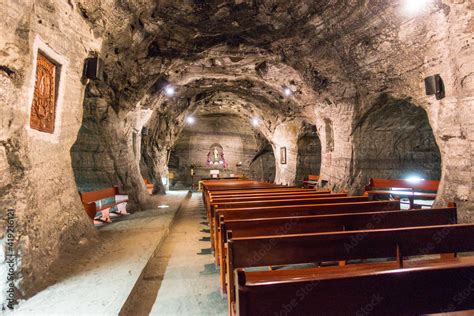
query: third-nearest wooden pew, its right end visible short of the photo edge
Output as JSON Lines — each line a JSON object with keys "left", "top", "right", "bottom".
{"left": 216, "top": 208, "right": 457, "bottom": 291}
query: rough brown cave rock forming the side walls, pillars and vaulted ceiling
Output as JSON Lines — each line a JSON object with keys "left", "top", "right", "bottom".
{"left": 0, "top": 0, "right": 474, "bottom": 304}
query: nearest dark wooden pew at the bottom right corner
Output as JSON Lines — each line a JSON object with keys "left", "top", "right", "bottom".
{"left": 236, "top": 257, "right": 474, "bottom": 316}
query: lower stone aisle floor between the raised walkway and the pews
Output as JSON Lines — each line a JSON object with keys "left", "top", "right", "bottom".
{"left": 121, "top": 193, "right": 227, "bottom": 315}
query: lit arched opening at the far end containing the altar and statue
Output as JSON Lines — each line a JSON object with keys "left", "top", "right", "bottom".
{"left": 163, "top": 113, "right": 275, "bottom": 190}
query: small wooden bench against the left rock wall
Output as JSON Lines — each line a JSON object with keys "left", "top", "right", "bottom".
{"left": 79, "top": 187, "right": 128, "bottom": 223}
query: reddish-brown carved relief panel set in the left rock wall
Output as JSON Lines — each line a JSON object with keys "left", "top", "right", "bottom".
{"left": 30, "top": 52, "right": 57, "bottom": 134}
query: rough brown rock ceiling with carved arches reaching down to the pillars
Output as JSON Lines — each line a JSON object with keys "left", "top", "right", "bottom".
{"left": 76, "top": 0, "right": 462, "bottom": 196}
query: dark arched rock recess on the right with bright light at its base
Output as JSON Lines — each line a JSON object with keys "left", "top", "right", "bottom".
{"left": 352, "top": 95, "right": 441, "bottom": 190}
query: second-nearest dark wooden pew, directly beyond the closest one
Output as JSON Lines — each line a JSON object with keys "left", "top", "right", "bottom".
{"left": 226, "top": 224, "right": 474, "bottom": 312}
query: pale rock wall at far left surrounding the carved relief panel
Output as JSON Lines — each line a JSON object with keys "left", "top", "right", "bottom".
{"left": 0, "top": 0, "right": 101, "bottom": 302}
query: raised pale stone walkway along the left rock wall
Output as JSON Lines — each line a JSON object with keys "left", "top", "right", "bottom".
{"left": 15, "top": 191, "right": 190, "bottom": 315}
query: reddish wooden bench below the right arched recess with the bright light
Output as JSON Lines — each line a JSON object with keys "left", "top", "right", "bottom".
{"left": 364, "top": 178, "right": 439, "bottom": 209}
